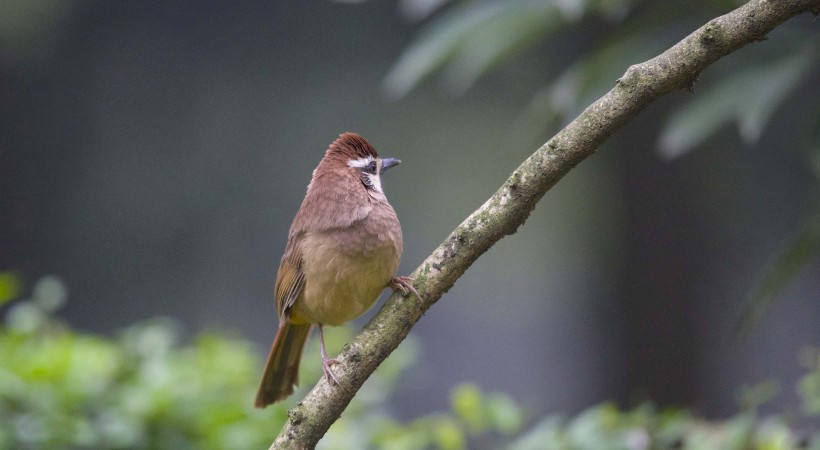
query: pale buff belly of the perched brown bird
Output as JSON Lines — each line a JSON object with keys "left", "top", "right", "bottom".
{"left": 291, "top": 230, "right": 401, "bottom": 325}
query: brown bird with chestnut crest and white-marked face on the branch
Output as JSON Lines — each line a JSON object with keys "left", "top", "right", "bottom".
{"left": 256, "top": 133, "right": 418, "bottom": 408}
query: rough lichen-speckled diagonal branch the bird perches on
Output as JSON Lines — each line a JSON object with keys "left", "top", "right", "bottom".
{"left": 271, "top": 0, "right": 820, "bottom": 449}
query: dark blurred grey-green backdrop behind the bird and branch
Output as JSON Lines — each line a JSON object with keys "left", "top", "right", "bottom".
{"left": 0, "top": 0, "right": 820, "bottom": 426}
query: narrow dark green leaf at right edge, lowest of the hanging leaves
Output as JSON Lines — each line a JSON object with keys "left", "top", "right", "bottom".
{"left": 738, "top": 214, "right": 820, "bottom": 333}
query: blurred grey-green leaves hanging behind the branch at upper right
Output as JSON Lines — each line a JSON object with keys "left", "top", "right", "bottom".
{"left": 383, "top": 0, "right": 820, "bottom": 330}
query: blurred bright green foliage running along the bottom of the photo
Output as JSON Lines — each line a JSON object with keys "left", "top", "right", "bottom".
{"left": 0, "top": 277, "right": 820, "bottom": 450}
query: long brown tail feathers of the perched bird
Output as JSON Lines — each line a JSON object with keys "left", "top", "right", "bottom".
{"left": 255, "top": 321, "right": 310, "bottom": 408}
